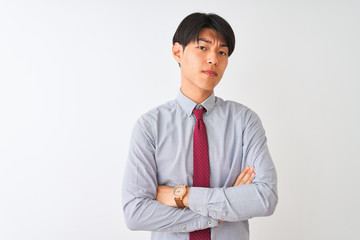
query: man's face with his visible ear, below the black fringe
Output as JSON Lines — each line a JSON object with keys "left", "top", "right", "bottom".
{"left": 173, "top": 28, "right": 228, "bottom": 93}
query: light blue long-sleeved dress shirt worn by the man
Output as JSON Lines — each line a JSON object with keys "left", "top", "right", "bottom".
{"left": 122, "top": 91, "right": 278, "bottom": 240}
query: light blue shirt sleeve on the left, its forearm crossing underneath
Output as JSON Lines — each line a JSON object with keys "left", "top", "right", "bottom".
{"left": 122, "top": 121, "right": 218, "bottom": 232}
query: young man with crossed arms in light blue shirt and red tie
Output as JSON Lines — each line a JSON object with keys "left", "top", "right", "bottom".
{"left": 123, "top": 13, "right": 277, "bottom": 240}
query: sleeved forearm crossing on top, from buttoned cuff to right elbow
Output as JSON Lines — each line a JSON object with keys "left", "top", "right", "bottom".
{"left": 189, "top": 183, "right": 278, "bottom": 222}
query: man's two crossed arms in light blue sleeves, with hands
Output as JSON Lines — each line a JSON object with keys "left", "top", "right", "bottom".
{"left": 122, "top": 114, "right": 277, "bottom": 232}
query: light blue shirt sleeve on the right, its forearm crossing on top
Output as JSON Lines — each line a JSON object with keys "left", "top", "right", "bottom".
{"left": 189, "top": 110, "right": 278, "bottom": 222}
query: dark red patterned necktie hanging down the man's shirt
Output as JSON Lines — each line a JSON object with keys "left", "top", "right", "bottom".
{"left": 190, "top": 108, "right": 211, "bottom": 240}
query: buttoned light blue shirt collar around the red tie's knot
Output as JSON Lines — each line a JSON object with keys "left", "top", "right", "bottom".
{"left": 176, "top": 90, "right": 216, "bottom": 117}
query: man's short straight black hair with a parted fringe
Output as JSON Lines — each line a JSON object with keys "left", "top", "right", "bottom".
{"left": 173, "top": 12, "right": 235, "bottom": 57}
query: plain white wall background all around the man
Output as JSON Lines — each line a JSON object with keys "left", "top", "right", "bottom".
{"left": 0, "top": 0, "right": 360, "bottom": 240}
